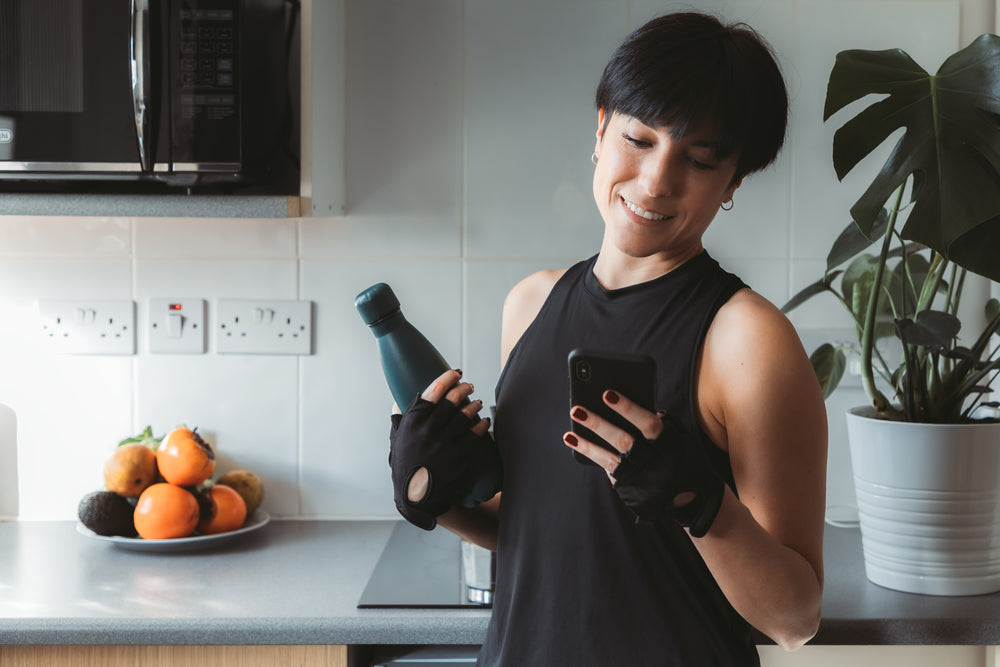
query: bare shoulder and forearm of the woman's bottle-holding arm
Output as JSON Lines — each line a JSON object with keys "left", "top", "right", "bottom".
{"left": 438, "top": 270, "right": 564, "bottom": 550}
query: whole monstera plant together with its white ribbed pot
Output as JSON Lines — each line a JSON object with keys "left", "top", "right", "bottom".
{"left": 784, "top": 35, "right": 1000, "bottom": 595}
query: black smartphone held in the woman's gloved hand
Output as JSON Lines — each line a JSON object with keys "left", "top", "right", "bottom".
{"left": 568, "top": 348, "right": 656, "bottom": 463}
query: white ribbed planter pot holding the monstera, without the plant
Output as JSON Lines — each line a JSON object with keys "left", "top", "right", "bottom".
{"left": 847, "top": 408, "right": 1000, "bottom": 595}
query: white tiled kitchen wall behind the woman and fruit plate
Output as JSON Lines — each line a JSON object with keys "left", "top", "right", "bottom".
{"left": 0, "top": 0, "right": 994, "bottom": 520}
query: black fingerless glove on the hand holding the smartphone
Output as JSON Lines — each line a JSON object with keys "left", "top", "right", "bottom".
{"left": 612, "top": 417, "right": 725, "bottom": 537}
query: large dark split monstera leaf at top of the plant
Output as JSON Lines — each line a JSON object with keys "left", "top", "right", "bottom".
{"left": 824, "top": 35, "right": 1000, "bottom": 280}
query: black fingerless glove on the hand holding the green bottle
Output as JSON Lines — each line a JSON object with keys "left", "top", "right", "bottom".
{"left": 389, "top": 396, "right": 502, "bottom": 530}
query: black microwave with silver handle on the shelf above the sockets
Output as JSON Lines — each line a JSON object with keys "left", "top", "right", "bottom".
{"left": 0, "top": 0, "right": 299, "bottom": 194}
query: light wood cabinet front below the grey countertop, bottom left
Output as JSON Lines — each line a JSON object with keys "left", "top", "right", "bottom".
{"left": 0, "top": 646, "right": 347, "bottom": 667}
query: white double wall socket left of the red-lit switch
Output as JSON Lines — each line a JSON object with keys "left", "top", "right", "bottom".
{"left": 38, "top": 299, "right": 135, "bottom": 354}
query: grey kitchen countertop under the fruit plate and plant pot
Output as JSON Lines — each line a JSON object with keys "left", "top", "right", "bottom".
{"left": 0, "top": 521, "right": 1000, "bottom": 645}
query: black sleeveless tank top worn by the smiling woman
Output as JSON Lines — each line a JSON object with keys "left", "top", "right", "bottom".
{"left": 478, "top": 252, "right": 759, "bottom": 667}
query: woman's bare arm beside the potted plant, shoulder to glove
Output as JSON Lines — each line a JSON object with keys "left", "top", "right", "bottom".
{"left": 694, "top": 290, "right": 827, "bottom": 650}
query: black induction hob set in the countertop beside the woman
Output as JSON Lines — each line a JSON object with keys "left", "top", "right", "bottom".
{"left": 358, "top": 522, "right": 491, "bottom": 609}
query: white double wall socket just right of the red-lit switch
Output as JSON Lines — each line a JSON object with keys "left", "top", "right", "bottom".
{"left": 215, "top": 299, "right": 312, "bottom": 354}
